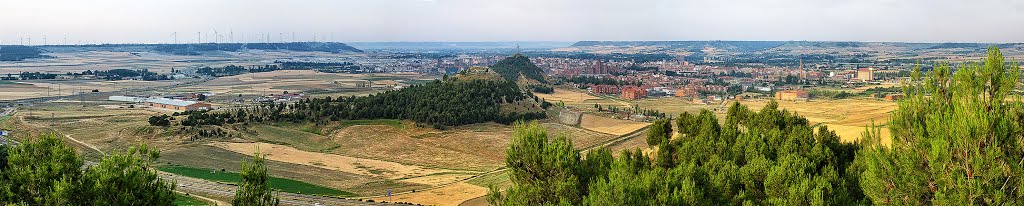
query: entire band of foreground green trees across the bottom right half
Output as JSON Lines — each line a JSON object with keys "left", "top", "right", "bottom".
{"left": 487, "top": 48, "right": 1024, "bottom": 205}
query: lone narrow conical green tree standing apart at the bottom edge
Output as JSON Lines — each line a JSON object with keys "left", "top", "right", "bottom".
{"left": 231, "top": 152, "right": 281, "bottom": 206}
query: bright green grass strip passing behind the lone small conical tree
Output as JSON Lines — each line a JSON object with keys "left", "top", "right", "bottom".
{"left": 158, "top": 166, "right": 355, "bottom": 197}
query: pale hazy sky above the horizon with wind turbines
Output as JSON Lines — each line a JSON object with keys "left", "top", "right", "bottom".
{"left": 0, "top": 0, "right": 1024, "bottom": 44}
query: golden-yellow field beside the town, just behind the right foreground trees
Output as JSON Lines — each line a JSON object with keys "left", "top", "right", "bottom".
{"left": 741, "top": 98, "right": 897, "bottom": 143}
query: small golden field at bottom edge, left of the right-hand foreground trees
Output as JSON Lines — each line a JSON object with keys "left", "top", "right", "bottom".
{"left": 374, "top": 182, "right": 487, "bottom": 205}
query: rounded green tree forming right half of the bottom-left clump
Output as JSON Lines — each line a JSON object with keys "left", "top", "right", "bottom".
{"left": 82, "top": 145, "right": 176, "bottom": 205}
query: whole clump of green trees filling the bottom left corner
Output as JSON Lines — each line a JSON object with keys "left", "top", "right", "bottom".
{"left": 0, "top": 134, "right": 175, "bottom": 205}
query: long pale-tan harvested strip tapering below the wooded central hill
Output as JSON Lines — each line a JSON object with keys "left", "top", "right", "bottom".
{"left": 209, "top": 142, "right": 464, "bottom": 179}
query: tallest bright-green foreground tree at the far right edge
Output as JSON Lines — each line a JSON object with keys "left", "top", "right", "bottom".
{"left": 857, "top": 46, "right": 1024, "bottom": 205}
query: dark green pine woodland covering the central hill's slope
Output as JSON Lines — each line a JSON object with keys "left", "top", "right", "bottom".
{"left": 172, "top": 78, "right": 547, "bottom": 128}
